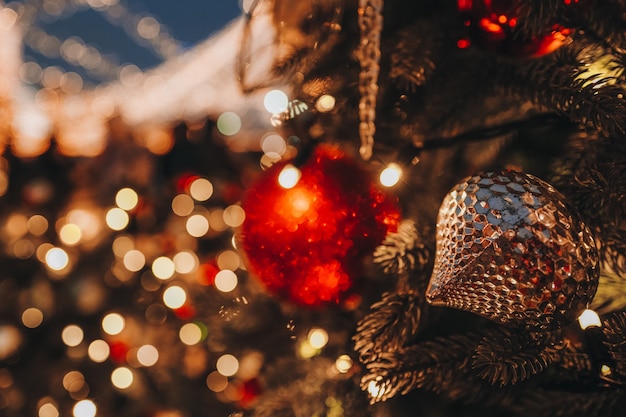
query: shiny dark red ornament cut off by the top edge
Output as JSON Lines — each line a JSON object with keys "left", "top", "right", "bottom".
{"left": 457, "top": 0, "right": 572, "bottom": 58}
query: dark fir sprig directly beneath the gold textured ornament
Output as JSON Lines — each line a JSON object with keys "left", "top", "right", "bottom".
{"left": 472, "top": 328, "right": 561, "bottom": 386}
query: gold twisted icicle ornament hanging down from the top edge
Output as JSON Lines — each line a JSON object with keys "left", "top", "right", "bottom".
{"left": 358, "top": 0, "right": 384, "bottom": 161}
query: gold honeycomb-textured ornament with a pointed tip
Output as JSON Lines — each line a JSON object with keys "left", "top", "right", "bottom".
{"left": 426, "top": 170, "right": 599, "bottom": 329}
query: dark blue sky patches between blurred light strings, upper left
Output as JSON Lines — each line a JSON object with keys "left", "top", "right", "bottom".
{"left": 25, "top": 0, "right": 241, "bottom": 82}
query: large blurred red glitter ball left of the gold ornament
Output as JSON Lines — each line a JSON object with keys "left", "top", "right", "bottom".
{"left": 241, "top": 145, "right": 400, "bottom": 306}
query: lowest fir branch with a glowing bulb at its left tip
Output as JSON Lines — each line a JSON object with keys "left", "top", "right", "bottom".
{"left": 361, "top": 334, "right": 482, "bottom": 404}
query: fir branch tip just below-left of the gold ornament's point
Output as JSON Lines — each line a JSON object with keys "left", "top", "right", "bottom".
{"left": 353, "top": 292, "right": 421, "bottom": 363}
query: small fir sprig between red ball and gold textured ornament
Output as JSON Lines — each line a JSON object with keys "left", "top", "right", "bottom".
{"left": 374, "top": 220, "right": 430, "bottom": 276}
